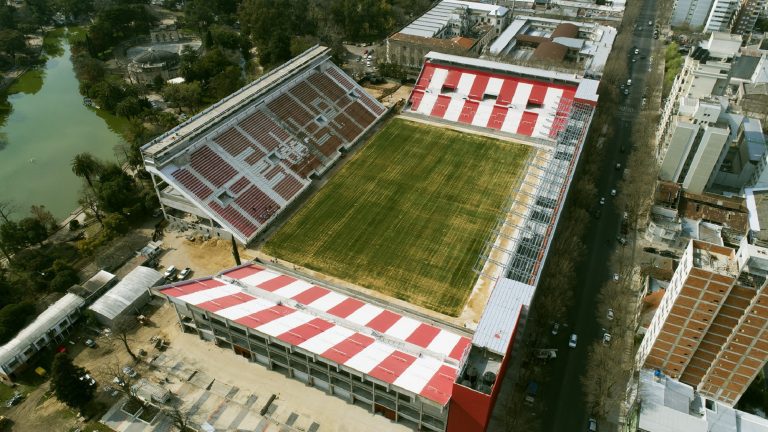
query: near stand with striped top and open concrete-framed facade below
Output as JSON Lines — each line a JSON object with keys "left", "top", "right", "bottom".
{"left": 157, "top": 265, "right": 474, "bottom": 431}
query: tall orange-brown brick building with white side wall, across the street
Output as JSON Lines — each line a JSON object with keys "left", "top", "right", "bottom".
{"left": 636, "top": 237, "right": 768, "bottom": 406}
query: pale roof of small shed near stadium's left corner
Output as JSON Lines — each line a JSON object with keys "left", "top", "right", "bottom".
{"left": 88, "top": 266, "right": 163, "bottom": 320}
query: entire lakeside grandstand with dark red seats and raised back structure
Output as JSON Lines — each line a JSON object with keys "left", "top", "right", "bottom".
{"left": 142, "top": 46, "right": 385, "bottom": 243}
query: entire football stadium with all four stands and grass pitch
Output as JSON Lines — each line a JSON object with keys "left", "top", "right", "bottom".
{"left": 142, "top": 47, "right": 598, "bottom": 431}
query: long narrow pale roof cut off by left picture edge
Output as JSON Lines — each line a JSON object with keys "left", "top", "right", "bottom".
{"left": 0, "top": 294, "right": 85, "bottom": 365}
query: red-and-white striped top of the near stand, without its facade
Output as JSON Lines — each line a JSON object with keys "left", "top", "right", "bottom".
{"left": 161, "top": 265, "right": 471, "bottom": 405}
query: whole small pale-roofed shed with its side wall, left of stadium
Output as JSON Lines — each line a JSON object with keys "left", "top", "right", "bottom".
{"left": 88, "top": 266, "right": 165, "bottom": 328}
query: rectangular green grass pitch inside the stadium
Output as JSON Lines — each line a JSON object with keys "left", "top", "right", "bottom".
{"left": 265, "top": 119, "right": 532, "bottom": 316}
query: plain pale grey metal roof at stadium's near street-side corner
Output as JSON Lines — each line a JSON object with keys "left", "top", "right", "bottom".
{"left": 472, "top": 278, "right": 536, "bottom": 356}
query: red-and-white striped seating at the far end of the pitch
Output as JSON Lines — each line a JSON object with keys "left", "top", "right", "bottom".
{"left": 409, "top": 62, "right": 577, "bottom": 139}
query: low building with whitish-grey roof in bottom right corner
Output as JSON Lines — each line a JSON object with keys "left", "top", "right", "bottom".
{"left": 634, "top": 369, "right": 768, "bottom": 432}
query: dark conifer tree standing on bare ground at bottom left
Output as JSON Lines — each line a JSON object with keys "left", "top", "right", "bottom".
{"left": 51, "top": 353, "right": 96, "bottom": 411}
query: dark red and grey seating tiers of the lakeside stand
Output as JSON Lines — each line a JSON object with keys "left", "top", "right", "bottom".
{"left": 160, "top": 62, "right": 385, "bottom": 245}
